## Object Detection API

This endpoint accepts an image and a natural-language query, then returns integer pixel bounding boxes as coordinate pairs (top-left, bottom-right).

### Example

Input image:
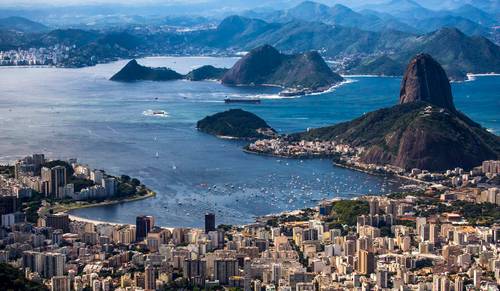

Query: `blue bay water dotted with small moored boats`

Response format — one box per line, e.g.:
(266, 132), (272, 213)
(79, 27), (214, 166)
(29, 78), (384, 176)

(0, 57), (500, 226)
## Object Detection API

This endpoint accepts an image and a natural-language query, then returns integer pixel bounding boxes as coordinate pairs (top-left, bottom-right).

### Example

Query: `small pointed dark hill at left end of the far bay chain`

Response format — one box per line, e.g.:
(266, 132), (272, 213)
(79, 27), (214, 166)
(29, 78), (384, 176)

(110, 60), (184, 82)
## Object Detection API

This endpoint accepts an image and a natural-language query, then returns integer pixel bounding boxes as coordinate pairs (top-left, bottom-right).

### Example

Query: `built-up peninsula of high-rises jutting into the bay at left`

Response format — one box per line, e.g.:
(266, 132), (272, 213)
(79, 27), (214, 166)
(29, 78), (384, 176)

(0, 154), (155, 223)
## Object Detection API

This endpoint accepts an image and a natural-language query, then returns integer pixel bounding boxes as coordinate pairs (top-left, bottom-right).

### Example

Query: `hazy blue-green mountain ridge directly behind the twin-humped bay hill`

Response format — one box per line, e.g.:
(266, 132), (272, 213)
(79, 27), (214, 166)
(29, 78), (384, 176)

(191, 16), (500, 80)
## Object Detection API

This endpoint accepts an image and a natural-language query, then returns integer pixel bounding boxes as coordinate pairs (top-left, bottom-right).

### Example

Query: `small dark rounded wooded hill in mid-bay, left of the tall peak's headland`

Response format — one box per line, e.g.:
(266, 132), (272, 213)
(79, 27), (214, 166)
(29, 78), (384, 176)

(196, 109), (276, 139)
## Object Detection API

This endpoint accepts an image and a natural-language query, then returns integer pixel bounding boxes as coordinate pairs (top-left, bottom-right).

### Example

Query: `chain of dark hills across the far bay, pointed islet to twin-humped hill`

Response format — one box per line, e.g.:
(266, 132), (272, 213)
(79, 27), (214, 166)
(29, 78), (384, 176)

(111, 45), (344, 96)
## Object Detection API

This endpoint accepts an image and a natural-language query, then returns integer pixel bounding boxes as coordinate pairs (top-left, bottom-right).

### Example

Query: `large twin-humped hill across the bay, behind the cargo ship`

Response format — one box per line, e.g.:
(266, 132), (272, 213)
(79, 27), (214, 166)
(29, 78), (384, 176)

(222, 45), (343, 91)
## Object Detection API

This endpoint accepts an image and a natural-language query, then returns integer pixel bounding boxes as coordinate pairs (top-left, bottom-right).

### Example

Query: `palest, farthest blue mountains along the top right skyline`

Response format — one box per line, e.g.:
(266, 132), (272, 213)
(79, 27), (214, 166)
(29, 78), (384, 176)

(242, 0), (500, 37)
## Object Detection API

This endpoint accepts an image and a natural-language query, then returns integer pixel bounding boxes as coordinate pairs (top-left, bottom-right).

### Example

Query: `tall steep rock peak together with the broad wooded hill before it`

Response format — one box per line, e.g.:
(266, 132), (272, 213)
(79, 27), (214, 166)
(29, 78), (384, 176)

(293, 55), (500, 170)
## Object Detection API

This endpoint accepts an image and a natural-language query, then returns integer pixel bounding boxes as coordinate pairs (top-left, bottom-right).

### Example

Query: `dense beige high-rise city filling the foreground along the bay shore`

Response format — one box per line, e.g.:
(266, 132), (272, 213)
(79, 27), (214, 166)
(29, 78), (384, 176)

(0, 154), (500, 291)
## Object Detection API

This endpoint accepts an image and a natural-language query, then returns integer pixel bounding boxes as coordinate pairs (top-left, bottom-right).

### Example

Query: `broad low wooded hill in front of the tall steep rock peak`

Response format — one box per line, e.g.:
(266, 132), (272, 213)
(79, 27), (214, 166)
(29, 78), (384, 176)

(292, 102), (500, 170)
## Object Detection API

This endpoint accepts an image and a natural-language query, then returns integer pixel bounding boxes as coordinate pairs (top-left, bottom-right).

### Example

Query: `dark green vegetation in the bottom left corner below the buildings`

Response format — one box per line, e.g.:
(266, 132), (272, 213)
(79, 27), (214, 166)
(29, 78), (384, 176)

(0, 263), (48, 291)
